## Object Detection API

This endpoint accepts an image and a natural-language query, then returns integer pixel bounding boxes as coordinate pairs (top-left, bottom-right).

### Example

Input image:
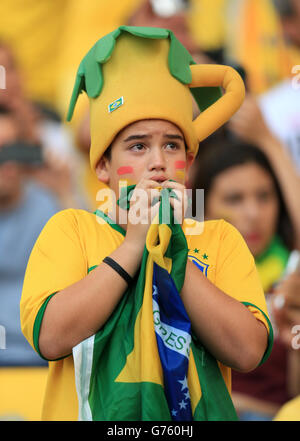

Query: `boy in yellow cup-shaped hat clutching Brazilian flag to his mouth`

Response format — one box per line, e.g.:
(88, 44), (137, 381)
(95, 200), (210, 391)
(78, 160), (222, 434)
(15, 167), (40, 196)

(21, 26), (272, 421)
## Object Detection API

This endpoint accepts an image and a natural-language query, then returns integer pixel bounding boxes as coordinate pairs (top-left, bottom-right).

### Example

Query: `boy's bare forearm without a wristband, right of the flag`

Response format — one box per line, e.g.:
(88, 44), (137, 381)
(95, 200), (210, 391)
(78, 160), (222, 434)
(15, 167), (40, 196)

(181, 260), (267, 372)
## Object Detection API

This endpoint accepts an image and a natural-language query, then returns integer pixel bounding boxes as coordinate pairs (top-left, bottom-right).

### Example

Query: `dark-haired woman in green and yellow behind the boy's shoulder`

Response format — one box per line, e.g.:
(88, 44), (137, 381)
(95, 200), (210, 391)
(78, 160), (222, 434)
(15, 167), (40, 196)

(190, 137), (299, 420)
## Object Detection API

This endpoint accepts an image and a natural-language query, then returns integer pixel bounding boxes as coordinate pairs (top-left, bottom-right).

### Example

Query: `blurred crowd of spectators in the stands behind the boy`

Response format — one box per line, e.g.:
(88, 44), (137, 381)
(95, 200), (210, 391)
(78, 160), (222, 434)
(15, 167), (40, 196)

(0, 0), (300, 421)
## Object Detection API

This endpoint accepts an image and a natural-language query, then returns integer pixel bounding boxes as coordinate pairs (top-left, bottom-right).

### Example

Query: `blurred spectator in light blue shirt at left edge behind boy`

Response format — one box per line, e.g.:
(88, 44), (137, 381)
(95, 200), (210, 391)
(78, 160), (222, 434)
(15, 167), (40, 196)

(0, 107), (61, 366)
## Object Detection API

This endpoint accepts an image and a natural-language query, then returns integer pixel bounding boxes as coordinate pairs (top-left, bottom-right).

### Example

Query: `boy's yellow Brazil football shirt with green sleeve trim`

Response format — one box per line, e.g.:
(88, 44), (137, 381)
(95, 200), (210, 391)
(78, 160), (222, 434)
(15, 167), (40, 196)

(21, 209), (269, 420)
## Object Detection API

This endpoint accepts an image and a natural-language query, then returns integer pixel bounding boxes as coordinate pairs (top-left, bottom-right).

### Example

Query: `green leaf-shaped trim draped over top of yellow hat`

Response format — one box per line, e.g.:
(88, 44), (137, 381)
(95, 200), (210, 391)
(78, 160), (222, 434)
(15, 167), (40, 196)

(67, 26), (221, 121)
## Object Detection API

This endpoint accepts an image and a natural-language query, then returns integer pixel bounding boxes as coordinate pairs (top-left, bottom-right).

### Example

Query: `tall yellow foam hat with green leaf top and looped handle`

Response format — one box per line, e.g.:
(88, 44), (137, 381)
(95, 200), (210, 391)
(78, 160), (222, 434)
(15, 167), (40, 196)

(67, 26), (245, 169)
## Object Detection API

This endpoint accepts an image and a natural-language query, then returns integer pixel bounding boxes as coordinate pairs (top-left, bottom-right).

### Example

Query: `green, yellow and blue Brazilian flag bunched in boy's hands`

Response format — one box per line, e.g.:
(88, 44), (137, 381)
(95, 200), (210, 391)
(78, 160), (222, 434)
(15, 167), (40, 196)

(73, 186), (237, 421)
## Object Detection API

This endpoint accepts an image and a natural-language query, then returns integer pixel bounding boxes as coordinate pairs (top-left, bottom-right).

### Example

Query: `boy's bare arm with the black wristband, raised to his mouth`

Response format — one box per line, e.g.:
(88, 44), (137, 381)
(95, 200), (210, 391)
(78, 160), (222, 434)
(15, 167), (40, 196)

(39, 180), (158, 360)
